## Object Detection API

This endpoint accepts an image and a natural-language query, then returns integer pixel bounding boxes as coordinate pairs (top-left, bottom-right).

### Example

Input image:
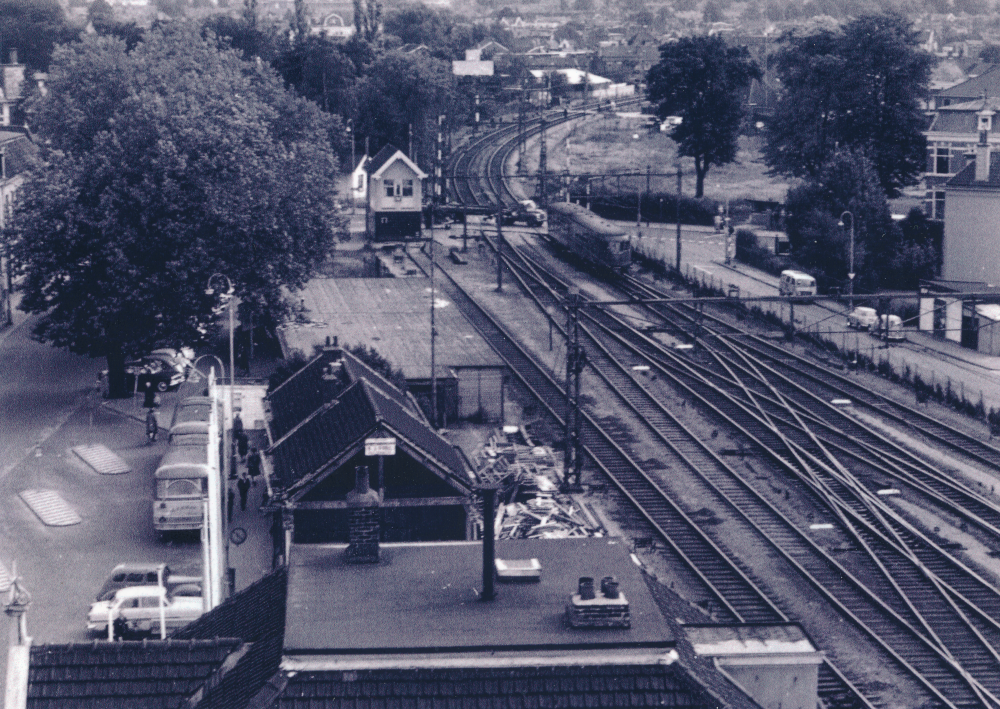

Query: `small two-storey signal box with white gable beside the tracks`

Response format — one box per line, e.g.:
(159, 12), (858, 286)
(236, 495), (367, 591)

(367, 144), (427, 242)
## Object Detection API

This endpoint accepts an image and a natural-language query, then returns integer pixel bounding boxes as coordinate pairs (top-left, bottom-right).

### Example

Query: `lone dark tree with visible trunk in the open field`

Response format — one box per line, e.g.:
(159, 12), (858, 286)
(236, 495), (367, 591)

(646, 35), (761, 197)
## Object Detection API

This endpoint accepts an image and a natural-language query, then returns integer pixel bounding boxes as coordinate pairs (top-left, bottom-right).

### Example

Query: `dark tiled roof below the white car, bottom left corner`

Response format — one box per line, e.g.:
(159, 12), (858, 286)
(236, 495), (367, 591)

(27, 638), (242, 709)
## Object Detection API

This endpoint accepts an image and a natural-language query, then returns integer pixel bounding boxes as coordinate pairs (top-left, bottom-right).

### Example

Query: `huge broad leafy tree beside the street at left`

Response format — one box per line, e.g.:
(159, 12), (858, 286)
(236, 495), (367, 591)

(13, 24), (344, 394)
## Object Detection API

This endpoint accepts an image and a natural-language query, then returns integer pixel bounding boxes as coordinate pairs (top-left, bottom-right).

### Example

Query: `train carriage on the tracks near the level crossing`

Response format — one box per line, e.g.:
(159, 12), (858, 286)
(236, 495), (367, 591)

(548, 202), (632, 273)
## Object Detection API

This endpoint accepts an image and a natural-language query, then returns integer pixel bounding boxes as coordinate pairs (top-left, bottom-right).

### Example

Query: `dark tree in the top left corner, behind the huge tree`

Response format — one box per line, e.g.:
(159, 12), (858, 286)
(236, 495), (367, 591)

(0, 0), (77, 72)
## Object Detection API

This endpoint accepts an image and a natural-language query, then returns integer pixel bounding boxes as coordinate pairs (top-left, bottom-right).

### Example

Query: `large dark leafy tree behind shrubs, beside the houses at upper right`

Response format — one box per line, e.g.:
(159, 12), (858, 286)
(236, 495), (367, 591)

(765, 14), (931, 197)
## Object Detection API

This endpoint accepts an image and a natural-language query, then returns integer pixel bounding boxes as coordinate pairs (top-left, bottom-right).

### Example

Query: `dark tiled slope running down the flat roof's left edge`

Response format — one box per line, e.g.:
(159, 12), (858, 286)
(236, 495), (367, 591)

(174, 567), (288, 709)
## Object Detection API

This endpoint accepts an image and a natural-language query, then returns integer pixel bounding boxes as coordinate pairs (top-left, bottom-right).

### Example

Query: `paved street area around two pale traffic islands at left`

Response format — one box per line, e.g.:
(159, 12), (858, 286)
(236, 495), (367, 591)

(0, 314), (199, 643)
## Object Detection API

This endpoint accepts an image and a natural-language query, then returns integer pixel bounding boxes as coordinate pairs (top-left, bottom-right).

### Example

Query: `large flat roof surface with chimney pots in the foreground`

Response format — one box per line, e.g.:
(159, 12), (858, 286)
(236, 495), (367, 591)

(285, 538), (673, 656)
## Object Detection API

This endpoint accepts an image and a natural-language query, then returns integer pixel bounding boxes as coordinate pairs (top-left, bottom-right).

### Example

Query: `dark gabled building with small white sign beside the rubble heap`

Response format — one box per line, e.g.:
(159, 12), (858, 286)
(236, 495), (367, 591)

(265, 347), (474, 554)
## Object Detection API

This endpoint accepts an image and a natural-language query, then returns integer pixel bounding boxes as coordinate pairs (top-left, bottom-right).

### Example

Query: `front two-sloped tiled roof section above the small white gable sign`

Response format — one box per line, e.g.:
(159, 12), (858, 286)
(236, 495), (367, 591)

(268, 379), (468, 490)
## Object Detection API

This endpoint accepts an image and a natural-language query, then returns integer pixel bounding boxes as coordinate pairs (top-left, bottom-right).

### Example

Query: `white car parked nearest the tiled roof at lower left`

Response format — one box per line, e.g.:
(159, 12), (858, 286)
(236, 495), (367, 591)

(87, 586), (205, 635)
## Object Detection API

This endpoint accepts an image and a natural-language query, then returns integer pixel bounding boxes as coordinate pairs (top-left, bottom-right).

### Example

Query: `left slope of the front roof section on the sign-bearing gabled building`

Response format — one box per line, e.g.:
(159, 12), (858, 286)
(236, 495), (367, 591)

(270, 382), (378, 487)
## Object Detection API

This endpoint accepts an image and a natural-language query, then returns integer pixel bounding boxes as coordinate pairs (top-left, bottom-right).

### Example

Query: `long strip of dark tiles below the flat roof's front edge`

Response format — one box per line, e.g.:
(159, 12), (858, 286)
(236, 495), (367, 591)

(278, 663), (732, 709)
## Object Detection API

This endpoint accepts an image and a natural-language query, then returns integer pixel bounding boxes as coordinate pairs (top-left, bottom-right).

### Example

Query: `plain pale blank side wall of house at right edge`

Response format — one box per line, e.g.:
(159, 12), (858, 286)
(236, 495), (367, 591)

(941, 188), (1000, 288)
